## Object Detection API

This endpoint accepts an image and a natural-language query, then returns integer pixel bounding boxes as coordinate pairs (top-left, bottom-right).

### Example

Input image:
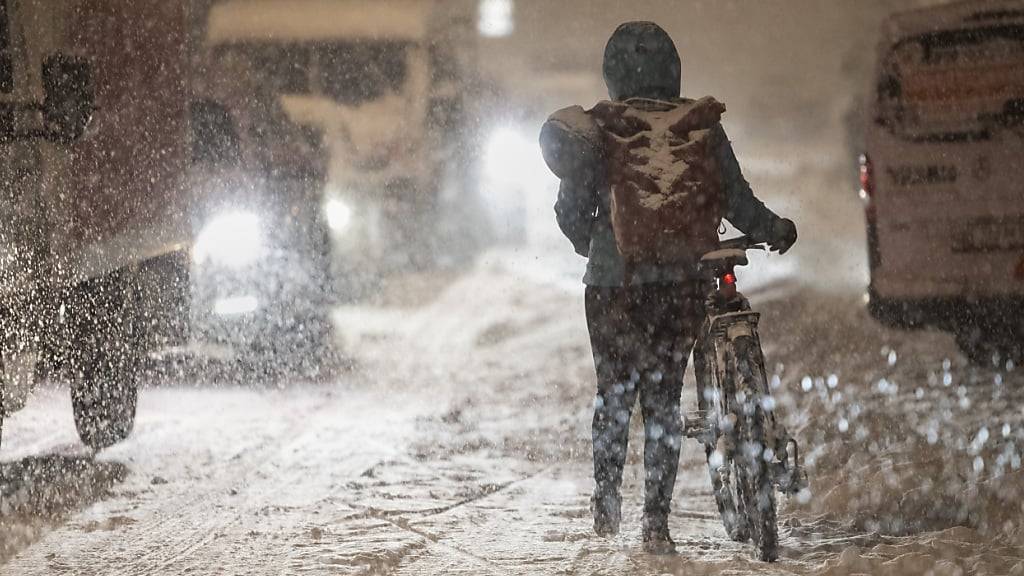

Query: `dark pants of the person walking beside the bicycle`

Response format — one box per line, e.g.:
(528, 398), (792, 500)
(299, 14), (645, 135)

(586, 283), (705, 523)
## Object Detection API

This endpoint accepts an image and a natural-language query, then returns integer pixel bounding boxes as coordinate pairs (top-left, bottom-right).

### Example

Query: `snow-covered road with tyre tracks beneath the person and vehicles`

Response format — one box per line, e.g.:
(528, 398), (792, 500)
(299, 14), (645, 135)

(0, 253), (1024, 576)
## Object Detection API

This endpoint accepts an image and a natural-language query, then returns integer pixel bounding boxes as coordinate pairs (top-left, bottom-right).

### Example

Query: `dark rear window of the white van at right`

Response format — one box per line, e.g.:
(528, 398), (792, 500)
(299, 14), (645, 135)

(878, 25), (1024, 139)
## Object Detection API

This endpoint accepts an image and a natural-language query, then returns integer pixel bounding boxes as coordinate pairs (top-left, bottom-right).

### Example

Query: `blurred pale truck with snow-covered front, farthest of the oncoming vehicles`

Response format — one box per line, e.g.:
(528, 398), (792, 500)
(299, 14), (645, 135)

(206, 0), (475, 284)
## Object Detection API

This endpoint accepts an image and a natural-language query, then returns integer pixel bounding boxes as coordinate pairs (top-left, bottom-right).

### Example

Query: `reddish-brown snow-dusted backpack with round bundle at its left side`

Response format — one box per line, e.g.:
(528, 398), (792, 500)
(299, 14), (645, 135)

(542, 97), (725, 272)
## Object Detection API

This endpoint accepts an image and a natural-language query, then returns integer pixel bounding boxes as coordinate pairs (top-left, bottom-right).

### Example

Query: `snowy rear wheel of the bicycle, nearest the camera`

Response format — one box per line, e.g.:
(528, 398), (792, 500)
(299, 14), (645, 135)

(729, 336), (778, 562)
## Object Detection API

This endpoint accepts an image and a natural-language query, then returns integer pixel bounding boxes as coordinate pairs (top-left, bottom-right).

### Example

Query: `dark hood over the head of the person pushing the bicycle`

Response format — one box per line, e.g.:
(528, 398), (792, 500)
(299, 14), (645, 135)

(604, 22), (682, 100)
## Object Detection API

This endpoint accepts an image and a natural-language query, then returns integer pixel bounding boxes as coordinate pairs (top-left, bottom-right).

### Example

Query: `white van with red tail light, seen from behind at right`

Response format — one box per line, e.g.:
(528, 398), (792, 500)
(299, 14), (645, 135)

(861, 0), (1024, 364)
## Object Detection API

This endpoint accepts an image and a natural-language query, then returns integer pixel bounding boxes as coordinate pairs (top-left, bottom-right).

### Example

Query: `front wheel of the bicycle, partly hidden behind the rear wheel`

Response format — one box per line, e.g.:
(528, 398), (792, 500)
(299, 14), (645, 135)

(693, 331), (750, 542)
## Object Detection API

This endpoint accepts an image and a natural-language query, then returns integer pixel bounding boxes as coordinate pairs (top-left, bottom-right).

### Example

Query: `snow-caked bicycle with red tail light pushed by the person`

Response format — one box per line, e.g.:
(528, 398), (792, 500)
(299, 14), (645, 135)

(684, 236), (807, 562)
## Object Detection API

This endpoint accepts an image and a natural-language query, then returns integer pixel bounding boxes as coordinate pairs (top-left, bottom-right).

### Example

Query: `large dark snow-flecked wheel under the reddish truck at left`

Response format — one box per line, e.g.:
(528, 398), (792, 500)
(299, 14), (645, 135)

(71, 280), (142, 450)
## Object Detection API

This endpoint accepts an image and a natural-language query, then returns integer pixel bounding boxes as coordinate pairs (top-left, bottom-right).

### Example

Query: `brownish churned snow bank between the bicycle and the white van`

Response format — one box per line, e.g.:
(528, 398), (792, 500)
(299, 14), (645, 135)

(755, 287), (1024, 575)
